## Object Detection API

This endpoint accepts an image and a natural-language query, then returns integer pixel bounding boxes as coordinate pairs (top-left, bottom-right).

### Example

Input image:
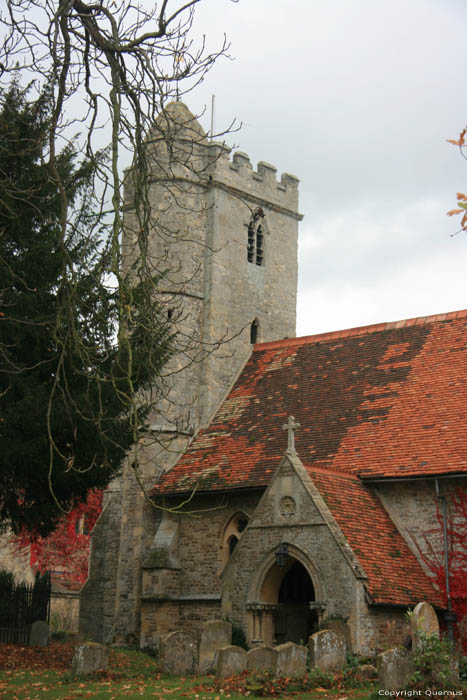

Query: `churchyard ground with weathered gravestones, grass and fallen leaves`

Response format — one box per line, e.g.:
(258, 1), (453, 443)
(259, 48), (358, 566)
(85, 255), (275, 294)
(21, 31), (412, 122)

(0, 603), (467, 700)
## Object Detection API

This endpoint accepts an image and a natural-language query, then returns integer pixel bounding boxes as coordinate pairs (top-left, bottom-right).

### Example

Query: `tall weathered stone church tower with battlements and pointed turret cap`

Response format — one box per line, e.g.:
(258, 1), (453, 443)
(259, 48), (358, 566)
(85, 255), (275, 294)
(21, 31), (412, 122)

(80, 102), (301, 642)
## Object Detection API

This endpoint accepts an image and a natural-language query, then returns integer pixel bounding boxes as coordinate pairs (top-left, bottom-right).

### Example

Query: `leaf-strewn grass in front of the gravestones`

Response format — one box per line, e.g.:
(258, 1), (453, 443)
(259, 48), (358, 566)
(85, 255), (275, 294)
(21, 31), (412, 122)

(0, 643), (371, 700)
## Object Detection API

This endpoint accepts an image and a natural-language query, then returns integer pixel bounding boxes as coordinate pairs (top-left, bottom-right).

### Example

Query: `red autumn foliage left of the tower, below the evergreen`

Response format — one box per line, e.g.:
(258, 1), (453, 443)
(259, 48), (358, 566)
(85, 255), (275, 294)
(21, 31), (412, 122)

(12, 491), (102, 589)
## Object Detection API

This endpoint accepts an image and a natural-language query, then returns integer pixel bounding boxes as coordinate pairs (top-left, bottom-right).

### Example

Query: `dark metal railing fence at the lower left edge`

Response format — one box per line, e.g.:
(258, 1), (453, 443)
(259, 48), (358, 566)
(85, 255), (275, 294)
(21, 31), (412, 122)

(0, 574), (51, 644)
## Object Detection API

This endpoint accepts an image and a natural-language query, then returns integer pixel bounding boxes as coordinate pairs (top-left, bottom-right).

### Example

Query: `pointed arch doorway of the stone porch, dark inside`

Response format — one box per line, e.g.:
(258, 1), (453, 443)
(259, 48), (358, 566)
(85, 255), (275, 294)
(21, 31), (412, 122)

(247, 549), (318, 644)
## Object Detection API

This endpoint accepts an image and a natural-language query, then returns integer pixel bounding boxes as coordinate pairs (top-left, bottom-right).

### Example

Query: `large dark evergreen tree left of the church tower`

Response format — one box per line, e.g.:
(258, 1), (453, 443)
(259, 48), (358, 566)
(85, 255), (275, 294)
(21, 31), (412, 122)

(0, 82), (170, 535)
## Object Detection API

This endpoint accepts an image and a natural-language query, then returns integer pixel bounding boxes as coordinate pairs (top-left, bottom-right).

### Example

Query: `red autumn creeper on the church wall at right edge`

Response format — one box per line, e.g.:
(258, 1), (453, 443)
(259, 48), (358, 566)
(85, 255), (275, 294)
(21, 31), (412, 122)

(417, 487), (467, 654)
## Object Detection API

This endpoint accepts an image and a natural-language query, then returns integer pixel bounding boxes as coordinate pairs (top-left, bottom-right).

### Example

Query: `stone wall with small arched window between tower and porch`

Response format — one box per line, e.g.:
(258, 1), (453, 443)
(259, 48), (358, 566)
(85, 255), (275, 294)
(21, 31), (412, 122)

(140, 492), (259, 647)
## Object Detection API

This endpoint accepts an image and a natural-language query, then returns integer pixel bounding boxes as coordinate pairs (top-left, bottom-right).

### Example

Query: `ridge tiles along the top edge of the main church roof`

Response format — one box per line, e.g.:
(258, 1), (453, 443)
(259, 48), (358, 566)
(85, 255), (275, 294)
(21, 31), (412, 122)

(253, 309), (467, 352)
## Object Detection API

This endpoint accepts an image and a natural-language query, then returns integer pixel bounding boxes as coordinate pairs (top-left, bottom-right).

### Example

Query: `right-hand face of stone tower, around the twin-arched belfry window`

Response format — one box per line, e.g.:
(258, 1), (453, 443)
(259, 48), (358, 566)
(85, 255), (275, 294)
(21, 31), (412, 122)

(203, 144), (301, 416)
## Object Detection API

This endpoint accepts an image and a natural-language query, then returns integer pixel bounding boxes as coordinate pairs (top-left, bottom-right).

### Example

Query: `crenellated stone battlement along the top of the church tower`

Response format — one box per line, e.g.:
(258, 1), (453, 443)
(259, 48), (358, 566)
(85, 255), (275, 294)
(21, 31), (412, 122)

(208, 141), (302, 213)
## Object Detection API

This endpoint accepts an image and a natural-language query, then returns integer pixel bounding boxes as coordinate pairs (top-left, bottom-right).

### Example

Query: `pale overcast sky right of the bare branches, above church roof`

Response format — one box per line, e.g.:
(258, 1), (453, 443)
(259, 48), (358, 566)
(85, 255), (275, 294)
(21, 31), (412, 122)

(186, 0), (467, 335)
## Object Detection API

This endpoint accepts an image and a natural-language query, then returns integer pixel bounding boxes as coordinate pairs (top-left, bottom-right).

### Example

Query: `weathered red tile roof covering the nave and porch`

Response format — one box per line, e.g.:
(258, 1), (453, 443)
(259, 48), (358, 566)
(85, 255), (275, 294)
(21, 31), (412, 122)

(154, 311), (467, 605)
